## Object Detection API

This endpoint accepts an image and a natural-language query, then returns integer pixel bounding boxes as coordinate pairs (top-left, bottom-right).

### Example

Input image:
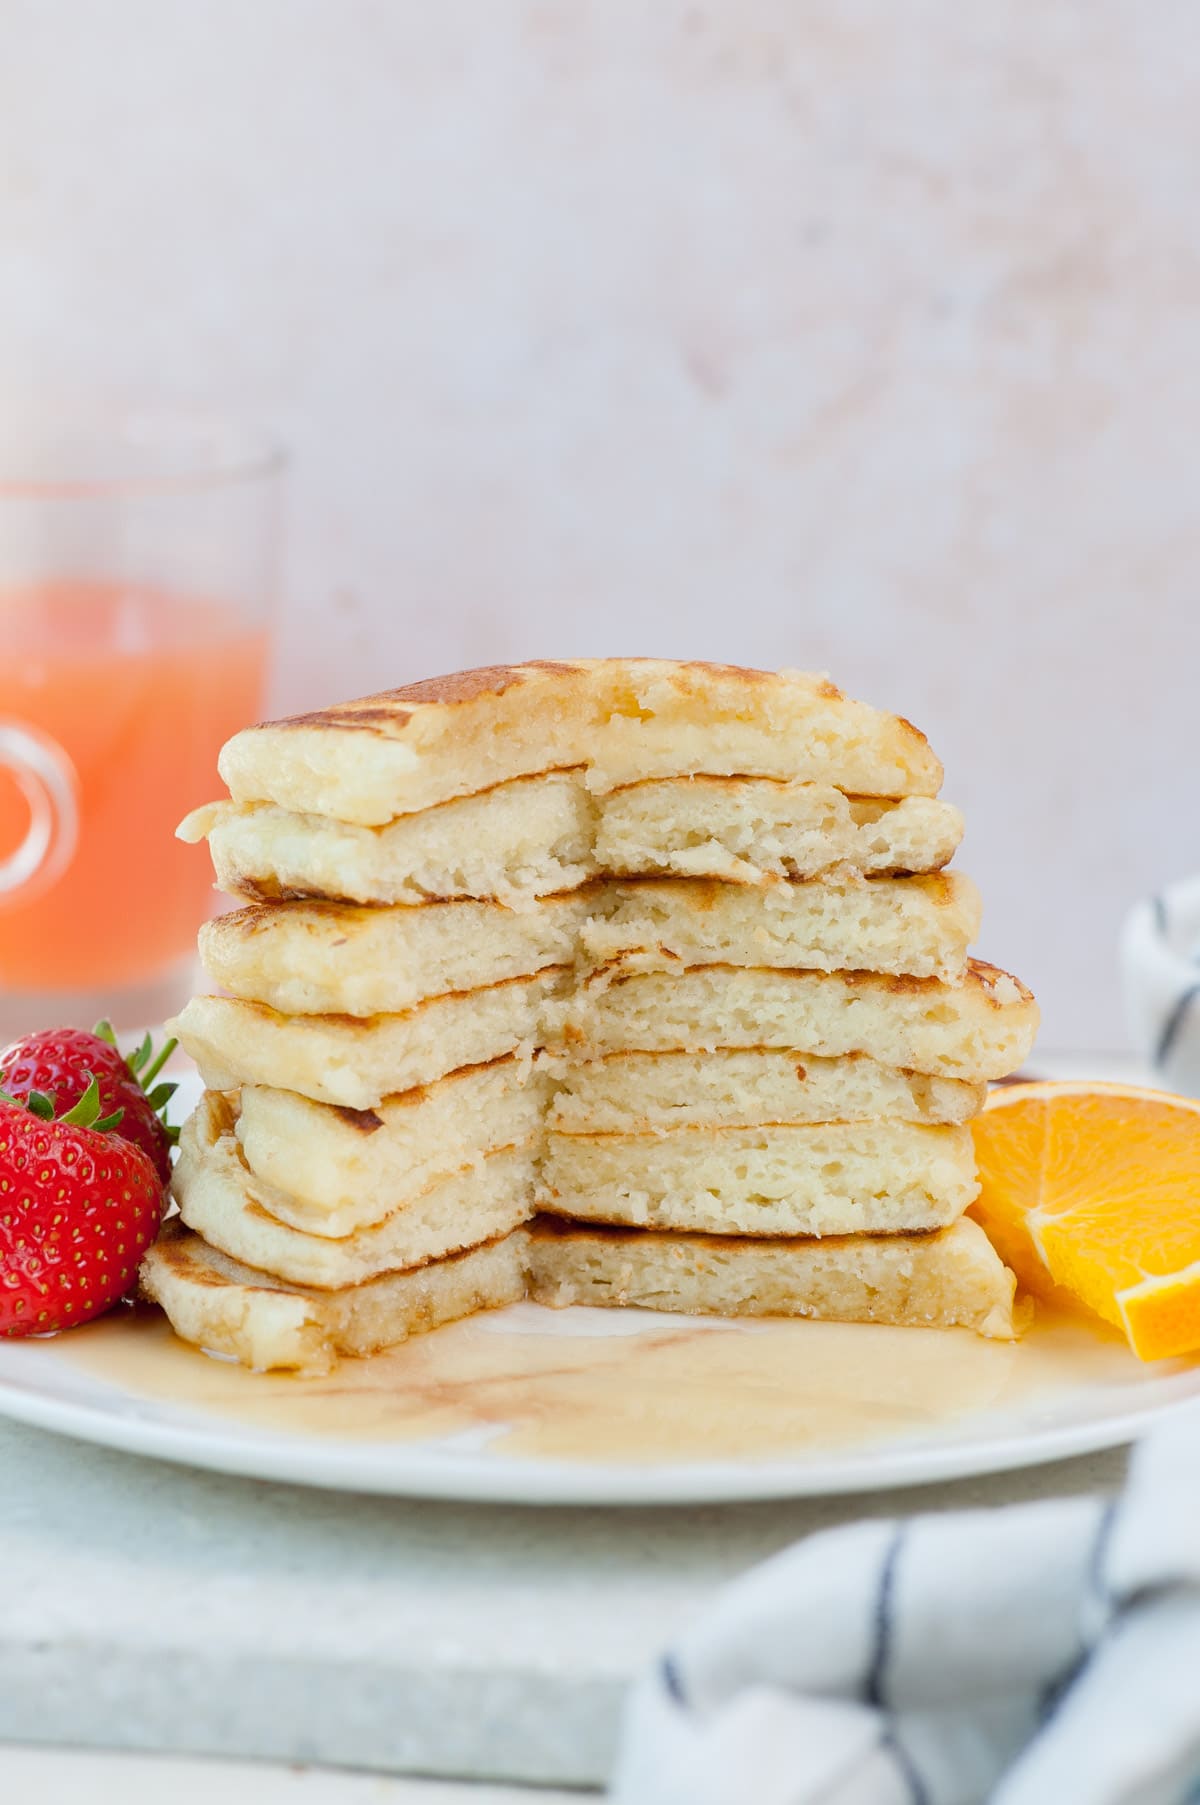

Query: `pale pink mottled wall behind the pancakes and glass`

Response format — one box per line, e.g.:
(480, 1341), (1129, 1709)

(0, 0), (1200, 1047)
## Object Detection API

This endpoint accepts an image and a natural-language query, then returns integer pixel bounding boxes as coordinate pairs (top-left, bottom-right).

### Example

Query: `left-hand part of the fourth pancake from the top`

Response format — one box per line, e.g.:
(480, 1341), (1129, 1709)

(168, 966), (570, 1110)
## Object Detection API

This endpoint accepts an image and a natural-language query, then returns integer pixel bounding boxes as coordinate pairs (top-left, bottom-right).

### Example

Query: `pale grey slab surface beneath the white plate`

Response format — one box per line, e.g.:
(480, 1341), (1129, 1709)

(0, 1424), (1124, 1785)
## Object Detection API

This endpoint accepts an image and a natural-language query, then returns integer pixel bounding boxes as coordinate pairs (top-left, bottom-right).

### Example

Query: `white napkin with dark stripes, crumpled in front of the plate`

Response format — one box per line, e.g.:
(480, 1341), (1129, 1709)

(612, 1410), (1200, 1805)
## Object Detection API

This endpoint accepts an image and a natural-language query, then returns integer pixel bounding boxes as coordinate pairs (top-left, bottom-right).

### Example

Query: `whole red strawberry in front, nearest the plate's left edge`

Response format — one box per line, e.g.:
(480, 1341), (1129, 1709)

(0, 1079), (164, 1338)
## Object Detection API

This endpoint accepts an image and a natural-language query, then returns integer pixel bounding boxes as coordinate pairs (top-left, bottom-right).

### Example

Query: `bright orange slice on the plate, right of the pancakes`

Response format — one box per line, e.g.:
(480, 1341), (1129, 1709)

(971, 1083), (1200, 1359)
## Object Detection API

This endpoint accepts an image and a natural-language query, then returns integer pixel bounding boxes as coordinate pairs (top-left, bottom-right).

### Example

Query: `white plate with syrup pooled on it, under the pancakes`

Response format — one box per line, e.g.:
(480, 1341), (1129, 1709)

(0, 1075), (1200, 1504)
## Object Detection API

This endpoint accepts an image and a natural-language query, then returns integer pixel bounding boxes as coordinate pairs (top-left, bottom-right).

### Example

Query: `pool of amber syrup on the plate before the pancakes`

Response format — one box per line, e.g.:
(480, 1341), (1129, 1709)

(45, 1305), (1144, 1464)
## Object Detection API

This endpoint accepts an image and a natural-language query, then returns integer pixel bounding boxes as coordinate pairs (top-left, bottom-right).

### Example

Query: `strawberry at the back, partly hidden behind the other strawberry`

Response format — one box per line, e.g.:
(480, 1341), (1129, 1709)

(0, 1022), (179, 1184)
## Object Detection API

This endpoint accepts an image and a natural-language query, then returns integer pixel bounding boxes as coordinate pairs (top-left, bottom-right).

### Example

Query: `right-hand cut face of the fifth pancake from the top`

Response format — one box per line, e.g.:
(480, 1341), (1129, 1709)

(543, 1047), (987, 1134)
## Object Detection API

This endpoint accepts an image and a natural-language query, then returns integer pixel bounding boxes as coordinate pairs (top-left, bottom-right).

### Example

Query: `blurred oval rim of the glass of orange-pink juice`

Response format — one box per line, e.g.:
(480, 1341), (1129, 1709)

(0, 413), (289, 504)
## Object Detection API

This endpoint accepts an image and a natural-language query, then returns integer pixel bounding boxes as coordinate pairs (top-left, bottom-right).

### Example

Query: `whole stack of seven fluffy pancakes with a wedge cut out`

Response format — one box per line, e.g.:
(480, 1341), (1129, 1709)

(143, 659), (1036, 1370)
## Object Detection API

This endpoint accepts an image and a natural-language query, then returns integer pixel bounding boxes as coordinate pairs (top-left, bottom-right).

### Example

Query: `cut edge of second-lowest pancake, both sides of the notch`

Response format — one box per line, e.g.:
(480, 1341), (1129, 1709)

(173, 1097), (976, 1249)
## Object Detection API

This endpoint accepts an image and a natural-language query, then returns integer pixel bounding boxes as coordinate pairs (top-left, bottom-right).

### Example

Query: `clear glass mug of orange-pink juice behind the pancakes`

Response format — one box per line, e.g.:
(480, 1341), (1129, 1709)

(0, 419), (283, 1040)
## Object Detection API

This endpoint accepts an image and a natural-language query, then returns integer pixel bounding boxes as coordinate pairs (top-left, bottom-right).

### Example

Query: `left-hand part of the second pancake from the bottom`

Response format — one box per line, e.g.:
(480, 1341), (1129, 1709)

(173, 1097), (532, 1291)
